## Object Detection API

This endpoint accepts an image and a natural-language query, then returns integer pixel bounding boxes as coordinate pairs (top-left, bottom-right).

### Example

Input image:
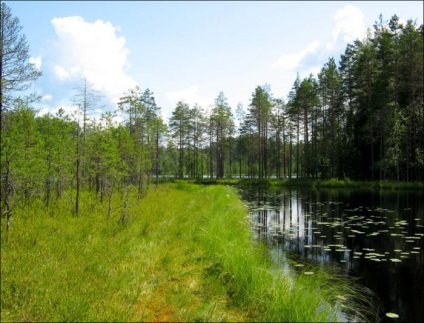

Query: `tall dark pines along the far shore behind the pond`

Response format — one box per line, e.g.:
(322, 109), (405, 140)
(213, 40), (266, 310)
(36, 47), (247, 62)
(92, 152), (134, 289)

(167, 15), (424, 181)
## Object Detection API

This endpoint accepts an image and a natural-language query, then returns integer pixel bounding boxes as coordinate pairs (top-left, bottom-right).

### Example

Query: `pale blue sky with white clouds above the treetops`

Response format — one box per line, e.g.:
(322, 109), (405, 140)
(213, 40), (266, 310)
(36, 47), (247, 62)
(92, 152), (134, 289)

(6, 1), (423, 123)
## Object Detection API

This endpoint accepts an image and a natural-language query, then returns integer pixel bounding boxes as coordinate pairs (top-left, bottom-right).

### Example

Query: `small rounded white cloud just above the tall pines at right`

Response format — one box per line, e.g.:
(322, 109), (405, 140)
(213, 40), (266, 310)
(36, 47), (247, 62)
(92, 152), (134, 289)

(327, 4), (367, 49)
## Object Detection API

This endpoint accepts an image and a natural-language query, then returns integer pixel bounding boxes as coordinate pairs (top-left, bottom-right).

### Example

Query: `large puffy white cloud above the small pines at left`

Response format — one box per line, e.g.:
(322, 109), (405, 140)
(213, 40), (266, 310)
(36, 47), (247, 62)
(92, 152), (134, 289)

(51, 16), (136, 103)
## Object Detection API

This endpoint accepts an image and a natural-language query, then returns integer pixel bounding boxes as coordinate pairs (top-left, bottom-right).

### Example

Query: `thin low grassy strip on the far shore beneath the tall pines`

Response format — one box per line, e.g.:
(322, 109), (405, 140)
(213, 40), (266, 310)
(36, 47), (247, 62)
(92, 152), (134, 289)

(197, 178), (424, 190)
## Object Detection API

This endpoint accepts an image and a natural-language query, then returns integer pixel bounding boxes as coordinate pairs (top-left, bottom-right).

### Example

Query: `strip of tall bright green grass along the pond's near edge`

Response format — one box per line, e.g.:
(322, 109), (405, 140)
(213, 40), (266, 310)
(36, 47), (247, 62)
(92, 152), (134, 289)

(197, 187), (372, 322)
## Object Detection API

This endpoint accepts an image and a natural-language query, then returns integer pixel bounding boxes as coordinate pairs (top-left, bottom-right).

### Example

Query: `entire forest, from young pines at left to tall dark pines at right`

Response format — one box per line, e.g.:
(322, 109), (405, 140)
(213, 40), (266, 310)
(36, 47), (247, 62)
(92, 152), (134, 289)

(1, 4), (424, 223)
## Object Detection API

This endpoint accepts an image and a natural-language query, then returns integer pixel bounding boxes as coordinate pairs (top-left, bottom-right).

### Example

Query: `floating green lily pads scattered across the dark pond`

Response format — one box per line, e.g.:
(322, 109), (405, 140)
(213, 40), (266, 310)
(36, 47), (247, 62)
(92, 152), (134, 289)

(243, 192), (424, 318)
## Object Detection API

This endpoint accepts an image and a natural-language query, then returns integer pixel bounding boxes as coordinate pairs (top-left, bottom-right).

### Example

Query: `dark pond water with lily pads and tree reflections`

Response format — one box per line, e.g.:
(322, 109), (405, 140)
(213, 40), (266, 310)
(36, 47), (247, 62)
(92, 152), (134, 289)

(240, 188), (424, 322)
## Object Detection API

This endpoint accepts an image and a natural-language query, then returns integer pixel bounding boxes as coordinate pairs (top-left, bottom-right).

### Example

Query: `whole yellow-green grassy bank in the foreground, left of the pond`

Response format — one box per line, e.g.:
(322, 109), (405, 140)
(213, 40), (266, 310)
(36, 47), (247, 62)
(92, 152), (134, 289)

(1, 182), (370, 322)
